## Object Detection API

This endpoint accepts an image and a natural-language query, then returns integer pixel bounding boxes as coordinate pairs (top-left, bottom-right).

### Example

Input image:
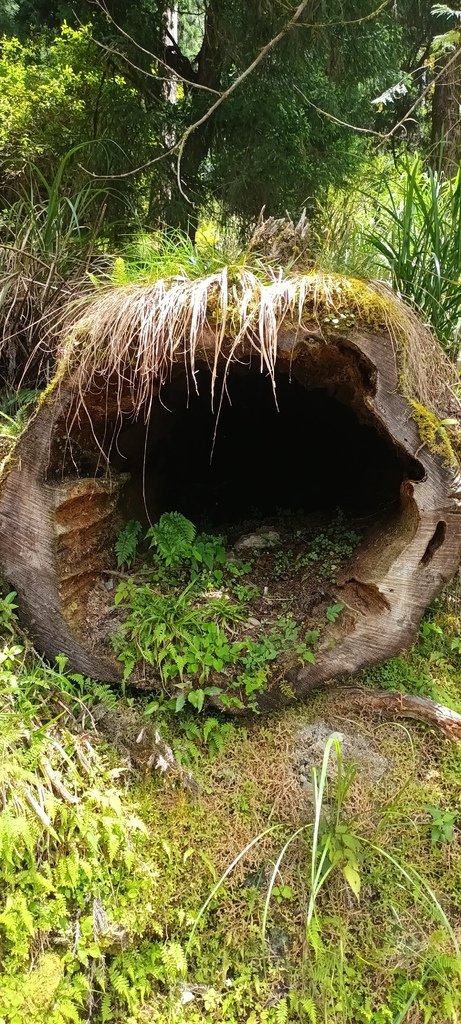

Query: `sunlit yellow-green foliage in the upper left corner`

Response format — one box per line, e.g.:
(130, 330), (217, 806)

(0, 23), (150, 207)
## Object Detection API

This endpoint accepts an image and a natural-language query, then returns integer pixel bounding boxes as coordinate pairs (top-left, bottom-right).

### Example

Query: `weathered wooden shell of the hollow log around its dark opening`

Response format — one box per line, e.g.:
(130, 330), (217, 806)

(0, 268), (461, 708)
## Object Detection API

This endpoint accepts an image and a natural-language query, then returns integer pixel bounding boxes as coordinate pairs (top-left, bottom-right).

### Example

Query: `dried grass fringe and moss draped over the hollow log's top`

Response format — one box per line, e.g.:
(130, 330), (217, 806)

(52, 267), (461, 416)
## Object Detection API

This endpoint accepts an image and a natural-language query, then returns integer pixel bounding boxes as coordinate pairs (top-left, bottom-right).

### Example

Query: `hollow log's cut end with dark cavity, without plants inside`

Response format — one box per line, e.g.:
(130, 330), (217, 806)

(0, 315), (461, 708)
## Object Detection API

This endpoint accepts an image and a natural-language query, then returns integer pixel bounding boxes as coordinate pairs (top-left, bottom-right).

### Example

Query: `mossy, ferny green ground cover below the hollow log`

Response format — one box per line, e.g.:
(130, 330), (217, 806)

(0, 577), (461, 1024)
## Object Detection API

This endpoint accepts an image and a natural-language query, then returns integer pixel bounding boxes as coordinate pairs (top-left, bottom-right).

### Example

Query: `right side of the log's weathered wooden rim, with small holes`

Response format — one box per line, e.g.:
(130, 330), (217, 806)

(261, 332), (461, 709)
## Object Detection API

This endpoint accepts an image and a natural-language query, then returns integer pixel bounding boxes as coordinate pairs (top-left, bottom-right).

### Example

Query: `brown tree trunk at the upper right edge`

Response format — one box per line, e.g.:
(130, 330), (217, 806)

(431, 42), (461, 177)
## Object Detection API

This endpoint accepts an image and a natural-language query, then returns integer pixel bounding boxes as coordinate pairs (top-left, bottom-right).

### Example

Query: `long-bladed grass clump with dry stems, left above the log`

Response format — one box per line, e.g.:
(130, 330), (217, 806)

(0, 147), (107, 381)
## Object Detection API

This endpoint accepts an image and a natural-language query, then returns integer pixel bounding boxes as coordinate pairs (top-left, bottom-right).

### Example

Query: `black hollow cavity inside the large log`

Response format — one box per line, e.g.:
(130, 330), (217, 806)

(111, 366), (420, 527)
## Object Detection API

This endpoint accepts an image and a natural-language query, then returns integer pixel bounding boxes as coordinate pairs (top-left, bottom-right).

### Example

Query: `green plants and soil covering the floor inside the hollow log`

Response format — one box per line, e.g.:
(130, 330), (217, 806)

(112, 512), (350, 712)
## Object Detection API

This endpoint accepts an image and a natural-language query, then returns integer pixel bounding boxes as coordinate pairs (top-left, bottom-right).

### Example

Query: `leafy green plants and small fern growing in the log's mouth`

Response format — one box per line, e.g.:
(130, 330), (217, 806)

(113, 512), (317, 712)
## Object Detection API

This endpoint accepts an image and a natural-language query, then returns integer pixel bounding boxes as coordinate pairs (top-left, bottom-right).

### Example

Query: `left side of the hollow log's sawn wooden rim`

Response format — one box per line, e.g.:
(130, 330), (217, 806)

(0, 395), (124, 679)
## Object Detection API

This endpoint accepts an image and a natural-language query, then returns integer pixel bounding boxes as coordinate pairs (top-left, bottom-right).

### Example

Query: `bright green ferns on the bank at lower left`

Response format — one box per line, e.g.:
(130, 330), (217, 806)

(0, 630), (177, 1024)
